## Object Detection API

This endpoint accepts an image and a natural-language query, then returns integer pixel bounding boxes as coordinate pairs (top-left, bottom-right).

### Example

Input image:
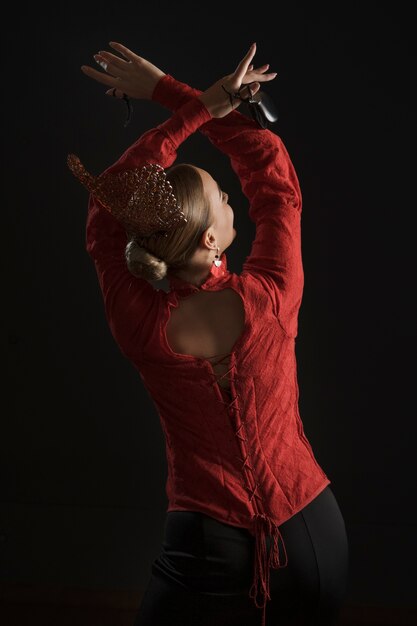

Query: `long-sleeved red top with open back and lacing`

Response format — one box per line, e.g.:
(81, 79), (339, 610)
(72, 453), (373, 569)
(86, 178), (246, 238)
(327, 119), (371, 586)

(86, 75), (330, 626)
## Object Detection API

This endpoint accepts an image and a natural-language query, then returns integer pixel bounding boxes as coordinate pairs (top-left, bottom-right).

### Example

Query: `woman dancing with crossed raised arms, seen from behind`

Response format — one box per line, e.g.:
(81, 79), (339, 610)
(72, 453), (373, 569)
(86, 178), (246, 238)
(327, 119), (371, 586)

(68, 42), (348, 626)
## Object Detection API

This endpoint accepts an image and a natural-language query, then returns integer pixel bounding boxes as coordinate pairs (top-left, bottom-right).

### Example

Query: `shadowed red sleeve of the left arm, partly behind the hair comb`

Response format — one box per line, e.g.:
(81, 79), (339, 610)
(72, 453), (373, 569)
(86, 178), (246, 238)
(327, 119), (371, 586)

(86, 98), (211, 360)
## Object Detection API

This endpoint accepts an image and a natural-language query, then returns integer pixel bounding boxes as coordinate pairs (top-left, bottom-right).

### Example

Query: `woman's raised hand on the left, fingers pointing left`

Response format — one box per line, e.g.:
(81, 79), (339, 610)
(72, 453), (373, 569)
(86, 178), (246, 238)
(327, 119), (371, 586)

(81, 41), (165, 100)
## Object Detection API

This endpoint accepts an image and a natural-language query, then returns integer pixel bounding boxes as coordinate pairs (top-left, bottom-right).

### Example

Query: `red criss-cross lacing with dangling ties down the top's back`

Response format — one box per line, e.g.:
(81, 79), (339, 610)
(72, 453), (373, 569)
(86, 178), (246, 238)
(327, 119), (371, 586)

(204, 353), (288, 626)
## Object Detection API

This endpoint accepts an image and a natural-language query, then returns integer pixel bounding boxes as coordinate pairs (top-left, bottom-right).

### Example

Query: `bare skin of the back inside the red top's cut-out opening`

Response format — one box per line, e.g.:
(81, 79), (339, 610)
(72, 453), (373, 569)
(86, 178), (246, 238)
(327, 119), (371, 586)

(166, 289), (245, 389)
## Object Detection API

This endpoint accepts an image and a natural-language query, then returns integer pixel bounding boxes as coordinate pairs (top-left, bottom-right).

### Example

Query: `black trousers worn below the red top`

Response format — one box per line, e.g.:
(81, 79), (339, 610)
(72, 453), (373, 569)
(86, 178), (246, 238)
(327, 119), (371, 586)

(134, 485), (349, 626)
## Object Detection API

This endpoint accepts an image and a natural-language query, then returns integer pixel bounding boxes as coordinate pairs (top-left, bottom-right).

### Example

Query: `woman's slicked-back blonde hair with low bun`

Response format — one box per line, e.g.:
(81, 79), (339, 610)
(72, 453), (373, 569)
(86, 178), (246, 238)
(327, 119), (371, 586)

(125, 163), (212, 281)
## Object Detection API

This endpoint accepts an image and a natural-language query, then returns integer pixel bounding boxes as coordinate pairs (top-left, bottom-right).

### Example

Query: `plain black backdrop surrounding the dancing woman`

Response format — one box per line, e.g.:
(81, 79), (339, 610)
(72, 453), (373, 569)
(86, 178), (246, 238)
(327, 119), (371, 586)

(0, 2), (416, 606)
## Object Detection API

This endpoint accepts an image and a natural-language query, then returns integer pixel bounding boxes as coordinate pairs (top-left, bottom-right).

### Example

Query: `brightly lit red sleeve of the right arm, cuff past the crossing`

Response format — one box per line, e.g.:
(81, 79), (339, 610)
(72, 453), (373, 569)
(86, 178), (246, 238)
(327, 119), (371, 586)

(153, 74), (304, 336)
